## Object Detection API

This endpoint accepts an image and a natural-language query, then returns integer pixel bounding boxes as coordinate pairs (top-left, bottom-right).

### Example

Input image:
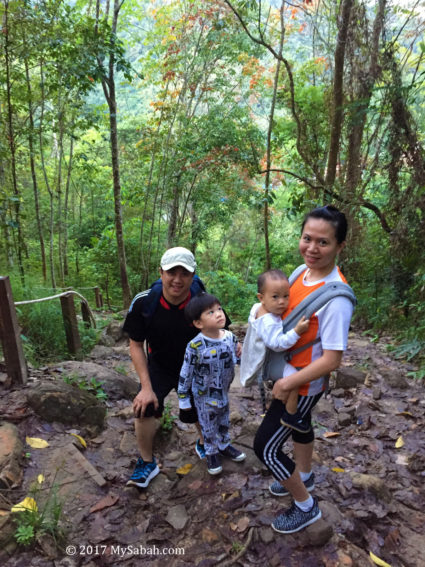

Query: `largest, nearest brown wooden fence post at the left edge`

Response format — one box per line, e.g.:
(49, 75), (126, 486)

(0, 276), (28, 384)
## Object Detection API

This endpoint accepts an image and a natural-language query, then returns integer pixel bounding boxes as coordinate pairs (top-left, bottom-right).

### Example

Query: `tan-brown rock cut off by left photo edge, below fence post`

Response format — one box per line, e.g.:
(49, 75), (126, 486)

(0, 423), (23, 490)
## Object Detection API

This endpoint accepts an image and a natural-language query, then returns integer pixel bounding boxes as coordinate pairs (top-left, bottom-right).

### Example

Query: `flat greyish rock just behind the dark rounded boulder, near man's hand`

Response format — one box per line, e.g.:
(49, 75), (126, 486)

(51, 360), (139, 400)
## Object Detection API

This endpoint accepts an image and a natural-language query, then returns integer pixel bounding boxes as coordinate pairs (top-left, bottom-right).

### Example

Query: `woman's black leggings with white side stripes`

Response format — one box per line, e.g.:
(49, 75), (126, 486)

(254, 392), (322, 480)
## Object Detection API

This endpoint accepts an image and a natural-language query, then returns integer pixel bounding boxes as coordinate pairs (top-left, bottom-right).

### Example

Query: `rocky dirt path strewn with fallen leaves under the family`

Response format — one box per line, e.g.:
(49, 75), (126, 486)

(0, 328), (425, 567)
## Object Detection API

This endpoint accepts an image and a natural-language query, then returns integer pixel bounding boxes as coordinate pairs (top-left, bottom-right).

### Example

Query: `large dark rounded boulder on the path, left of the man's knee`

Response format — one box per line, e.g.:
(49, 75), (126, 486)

(27, 380), (106, 430)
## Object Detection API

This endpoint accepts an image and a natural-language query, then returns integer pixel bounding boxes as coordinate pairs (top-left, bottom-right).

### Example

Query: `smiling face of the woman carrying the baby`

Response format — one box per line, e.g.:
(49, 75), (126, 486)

(299, 218), (345, 275)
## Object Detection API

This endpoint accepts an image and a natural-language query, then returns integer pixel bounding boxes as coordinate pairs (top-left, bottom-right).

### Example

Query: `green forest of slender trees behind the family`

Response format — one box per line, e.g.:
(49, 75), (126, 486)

(0, 0), (425, 370)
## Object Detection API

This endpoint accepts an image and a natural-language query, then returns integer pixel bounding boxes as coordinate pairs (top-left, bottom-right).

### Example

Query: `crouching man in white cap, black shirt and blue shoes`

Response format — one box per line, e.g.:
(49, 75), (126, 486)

(123, 247), (205, 488)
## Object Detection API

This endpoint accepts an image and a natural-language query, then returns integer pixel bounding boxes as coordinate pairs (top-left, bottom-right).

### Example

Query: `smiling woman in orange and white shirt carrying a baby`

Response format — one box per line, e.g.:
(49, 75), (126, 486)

(254, 205), (353, 533)
